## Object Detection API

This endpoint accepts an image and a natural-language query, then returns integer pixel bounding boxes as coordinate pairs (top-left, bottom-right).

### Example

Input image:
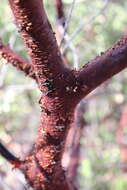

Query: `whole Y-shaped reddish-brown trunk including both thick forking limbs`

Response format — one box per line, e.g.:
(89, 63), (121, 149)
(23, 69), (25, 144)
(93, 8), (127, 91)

(0, 0), (127, 190)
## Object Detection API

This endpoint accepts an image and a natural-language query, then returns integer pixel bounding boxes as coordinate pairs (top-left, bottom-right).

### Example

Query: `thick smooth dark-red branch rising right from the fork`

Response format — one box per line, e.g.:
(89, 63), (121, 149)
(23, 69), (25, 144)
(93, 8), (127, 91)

(77, 36), (127, 97)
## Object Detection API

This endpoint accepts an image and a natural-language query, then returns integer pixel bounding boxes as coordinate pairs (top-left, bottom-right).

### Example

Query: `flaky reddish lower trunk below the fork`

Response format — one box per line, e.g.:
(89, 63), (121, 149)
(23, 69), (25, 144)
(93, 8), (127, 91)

(20, 97), (77, 190)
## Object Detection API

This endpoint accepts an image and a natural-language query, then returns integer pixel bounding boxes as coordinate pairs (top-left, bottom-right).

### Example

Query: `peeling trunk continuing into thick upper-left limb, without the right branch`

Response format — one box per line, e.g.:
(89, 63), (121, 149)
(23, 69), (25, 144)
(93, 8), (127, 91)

(9, 0), (77, 190)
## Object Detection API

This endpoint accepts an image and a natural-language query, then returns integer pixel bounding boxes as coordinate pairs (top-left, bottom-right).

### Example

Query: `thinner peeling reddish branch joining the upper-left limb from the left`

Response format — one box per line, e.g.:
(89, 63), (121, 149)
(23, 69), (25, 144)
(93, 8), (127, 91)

(0, 41), (37, 80)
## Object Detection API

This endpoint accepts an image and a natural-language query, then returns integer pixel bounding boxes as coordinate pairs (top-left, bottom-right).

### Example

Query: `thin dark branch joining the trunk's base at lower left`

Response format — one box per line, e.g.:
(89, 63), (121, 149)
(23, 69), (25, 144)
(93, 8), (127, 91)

(0, 142), (22, 168)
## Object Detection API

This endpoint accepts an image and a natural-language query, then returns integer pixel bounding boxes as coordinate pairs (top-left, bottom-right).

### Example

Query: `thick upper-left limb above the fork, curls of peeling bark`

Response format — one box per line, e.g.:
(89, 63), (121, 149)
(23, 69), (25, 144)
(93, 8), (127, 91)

(9, 0), (72, 95)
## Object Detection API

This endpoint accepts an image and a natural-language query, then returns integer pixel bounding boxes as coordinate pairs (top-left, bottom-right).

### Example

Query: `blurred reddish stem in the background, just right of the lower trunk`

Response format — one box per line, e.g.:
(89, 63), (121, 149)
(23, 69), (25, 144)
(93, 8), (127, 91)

(67, 100), (87, 186)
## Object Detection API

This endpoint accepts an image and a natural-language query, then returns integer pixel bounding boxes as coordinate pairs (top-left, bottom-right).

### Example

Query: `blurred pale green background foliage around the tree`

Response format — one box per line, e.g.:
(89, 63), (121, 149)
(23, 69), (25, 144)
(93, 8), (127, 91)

(0, 0), (127, 190)
